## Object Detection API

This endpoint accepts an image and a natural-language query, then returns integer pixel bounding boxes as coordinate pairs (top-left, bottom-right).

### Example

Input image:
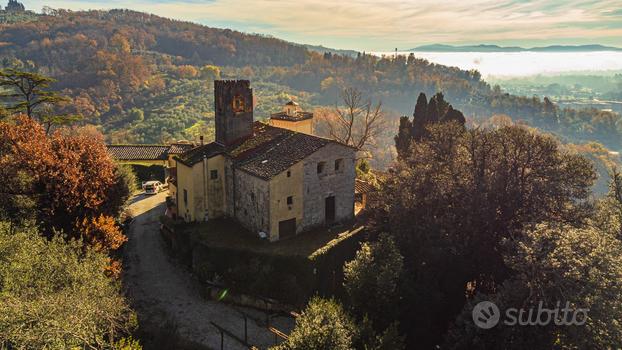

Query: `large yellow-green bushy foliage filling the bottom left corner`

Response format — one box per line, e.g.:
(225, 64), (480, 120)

(0, 223), (136, 349)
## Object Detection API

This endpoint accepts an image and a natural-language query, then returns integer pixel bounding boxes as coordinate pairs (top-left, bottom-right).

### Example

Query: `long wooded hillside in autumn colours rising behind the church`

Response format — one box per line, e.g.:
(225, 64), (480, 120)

(0, 9), (622, 157)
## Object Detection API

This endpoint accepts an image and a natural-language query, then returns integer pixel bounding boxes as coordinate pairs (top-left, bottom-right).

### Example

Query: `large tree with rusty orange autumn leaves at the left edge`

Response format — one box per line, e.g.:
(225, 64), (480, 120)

(0, 116), (127, 250)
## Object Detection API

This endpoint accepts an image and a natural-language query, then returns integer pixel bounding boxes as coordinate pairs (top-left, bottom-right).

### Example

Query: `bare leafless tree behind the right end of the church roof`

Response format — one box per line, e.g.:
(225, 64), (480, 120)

(320, 88), (385, 157)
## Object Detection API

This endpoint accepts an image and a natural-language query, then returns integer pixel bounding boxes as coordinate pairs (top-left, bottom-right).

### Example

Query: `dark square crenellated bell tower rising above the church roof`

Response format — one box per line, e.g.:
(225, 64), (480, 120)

(214, 80), (253, 146)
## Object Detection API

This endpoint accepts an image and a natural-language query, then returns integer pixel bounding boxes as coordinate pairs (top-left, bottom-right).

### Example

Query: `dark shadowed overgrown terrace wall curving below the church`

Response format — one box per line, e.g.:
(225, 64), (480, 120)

(162, 221), (367, 308)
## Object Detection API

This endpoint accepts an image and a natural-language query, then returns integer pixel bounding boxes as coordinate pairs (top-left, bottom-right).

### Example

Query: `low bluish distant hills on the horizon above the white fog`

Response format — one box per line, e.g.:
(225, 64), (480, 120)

(408, 44), (622, 52)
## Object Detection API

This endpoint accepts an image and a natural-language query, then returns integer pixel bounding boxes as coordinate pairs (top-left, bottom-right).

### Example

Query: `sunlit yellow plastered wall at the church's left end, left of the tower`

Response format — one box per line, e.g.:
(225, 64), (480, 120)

(177, 155), (226, 221)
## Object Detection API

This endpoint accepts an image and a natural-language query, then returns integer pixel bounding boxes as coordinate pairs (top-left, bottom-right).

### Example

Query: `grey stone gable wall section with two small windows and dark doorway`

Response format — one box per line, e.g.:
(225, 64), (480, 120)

(302, 143), (356, 230)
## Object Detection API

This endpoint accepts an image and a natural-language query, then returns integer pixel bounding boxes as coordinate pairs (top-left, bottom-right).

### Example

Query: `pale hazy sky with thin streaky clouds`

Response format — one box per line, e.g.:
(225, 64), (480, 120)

(23, 0), (622, 51)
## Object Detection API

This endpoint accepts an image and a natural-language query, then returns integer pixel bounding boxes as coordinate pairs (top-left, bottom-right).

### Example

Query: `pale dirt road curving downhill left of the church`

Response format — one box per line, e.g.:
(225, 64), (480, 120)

(123, 193), (293, 349)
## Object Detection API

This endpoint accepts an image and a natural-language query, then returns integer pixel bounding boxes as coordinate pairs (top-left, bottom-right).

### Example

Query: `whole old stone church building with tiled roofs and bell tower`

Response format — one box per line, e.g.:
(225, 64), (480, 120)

(171, 80), (356, 241)
